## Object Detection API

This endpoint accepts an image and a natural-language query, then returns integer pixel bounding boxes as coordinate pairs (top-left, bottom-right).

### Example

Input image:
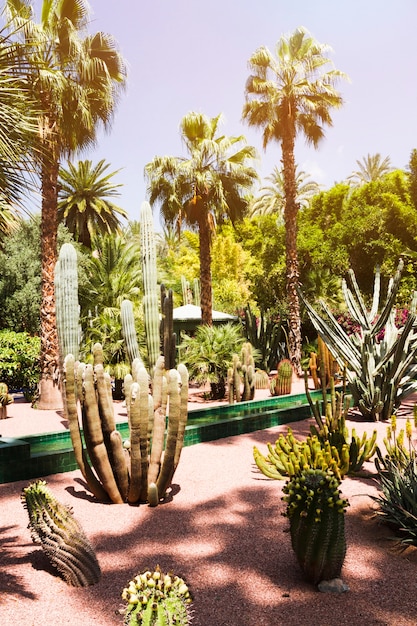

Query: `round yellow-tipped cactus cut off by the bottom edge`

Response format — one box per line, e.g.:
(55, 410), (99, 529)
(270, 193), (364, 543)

(122, 565), (192, 626)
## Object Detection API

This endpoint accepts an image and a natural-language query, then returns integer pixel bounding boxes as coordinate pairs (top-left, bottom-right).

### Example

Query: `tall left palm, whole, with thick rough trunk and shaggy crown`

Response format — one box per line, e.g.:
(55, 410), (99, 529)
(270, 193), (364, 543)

(6, 0), (125, 409)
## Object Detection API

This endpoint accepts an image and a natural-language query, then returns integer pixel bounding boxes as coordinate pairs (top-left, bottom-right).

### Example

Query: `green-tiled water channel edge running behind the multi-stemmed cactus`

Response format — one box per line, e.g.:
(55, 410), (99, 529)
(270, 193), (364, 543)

(0, 392), (321, 483)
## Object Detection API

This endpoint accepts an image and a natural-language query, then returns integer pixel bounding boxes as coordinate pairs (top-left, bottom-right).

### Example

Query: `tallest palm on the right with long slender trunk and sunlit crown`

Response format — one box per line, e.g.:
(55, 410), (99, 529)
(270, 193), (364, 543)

(243, 28), (345, 372)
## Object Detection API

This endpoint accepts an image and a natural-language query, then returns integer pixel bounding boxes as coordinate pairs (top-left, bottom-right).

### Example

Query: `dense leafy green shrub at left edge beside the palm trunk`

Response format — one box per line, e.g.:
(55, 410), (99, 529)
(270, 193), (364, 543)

(0, 330), (40, 399)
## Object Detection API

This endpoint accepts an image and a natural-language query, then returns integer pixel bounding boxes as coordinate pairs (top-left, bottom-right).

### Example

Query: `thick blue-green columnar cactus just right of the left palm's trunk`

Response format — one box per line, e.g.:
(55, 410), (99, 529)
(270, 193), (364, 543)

(54, 243), (80, 363)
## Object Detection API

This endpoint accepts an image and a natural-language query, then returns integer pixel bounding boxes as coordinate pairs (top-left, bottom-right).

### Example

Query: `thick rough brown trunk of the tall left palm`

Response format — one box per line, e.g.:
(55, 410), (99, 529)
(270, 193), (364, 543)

(37, 151), (62, 410)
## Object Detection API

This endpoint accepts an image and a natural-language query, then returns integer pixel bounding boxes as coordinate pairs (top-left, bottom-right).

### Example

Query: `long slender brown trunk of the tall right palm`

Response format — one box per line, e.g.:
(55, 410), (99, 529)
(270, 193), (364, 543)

(282, 124), (302, 375)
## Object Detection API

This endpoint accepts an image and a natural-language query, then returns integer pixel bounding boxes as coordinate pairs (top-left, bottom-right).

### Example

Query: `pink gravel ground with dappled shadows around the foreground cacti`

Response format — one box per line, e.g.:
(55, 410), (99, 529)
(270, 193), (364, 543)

(0, 382), (417, 626)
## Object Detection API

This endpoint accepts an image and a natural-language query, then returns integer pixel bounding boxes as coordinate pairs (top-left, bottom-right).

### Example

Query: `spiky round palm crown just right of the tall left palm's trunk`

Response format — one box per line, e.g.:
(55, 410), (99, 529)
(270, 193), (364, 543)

(58, 159), (127, 249)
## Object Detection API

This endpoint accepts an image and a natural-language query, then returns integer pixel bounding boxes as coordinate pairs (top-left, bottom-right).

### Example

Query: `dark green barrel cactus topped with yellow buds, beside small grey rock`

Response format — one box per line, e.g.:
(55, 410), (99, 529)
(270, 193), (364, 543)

(283, 468), (348, 584)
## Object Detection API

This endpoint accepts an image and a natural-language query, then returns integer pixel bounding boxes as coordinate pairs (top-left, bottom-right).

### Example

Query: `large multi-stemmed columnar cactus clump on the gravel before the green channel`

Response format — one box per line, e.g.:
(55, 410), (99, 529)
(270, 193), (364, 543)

(64, 344), (188, 506)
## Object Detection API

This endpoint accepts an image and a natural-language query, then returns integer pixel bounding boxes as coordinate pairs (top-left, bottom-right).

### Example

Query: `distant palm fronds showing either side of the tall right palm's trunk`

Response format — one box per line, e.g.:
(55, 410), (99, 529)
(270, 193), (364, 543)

(250, 167), (320, 217)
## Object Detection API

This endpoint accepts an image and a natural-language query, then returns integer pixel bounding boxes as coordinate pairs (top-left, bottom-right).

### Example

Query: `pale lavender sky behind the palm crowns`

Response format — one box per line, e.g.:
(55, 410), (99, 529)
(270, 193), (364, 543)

(66, 0), (417, 225)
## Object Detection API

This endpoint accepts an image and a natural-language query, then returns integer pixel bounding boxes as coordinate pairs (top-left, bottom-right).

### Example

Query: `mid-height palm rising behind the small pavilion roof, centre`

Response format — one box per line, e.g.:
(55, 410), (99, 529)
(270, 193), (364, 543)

(145, 112), (257, 325)
